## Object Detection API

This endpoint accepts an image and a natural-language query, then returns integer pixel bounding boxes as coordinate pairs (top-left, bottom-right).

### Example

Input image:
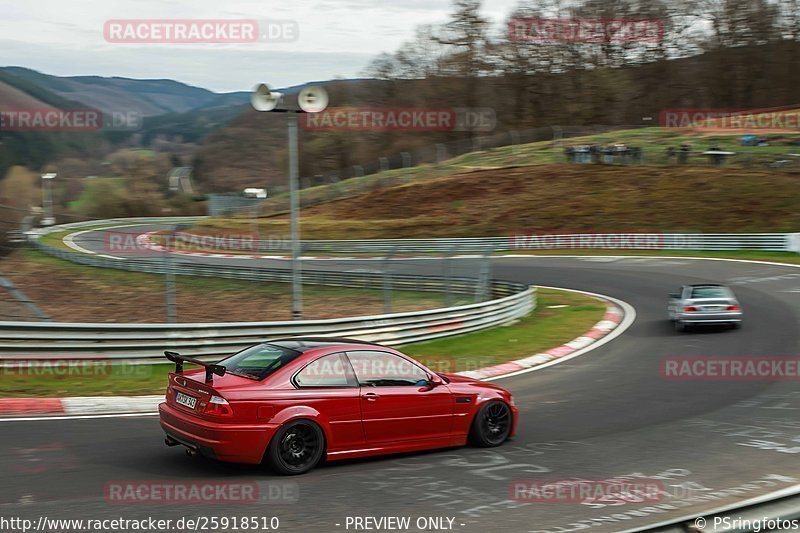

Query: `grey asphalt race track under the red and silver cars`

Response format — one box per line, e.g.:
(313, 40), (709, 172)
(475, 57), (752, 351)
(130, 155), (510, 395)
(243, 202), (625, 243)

(0, 224), (800, 532)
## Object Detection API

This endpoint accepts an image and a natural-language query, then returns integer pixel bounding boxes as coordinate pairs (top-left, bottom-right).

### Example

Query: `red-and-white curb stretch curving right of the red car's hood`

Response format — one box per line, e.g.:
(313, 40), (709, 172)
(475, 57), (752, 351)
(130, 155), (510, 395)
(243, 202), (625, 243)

(457, 302), (625, 379)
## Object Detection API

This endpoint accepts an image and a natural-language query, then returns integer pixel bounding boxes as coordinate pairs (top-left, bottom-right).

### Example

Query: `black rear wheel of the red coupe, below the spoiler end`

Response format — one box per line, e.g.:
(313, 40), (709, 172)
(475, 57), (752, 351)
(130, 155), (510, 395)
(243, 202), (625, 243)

(266, 419), (325, 476)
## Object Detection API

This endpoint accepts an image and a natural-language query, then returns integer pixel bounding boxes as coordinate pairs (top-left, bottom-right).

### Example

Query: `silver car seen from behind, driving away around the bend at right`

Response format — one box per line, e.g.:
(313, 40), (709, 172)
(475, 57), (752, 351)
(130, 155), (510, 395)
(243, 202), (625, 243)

(667, 283), (742, 331)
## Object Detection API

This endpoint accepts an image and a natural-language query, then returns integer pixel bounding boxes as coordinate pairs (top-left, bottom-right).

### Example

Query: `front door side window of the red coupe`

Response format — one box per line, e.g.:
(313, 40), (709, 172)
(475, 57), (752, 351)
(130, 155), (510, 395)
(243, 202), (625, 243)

(347, 350), (428, 387)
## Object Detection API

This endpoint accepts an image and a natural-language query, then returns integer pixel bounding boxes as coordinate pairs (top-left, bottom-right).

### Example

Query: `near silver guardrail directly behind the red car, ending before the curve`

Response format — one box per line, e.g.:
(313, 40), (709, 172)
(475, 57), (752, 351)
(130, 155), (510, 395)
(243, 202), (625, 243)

(0, 282), (536, 360)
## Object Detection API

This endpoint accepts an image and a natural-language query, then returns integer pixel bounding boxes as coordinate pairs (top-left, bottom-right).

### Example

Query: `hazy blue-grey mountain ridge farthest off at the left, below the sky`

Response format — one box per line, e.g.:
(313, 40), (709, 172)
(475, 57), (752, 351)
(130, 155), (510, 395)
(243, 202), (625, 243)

(0, 67), (250, 117)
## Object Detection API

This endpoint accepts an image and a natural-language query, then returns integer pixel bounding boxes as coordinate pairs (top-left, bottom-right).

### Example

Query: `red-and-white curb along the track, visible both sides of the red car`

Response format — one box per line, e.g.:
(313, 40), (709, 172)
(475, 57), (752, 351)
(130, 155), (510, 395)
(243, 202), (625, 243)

(0, 301), (625, 417)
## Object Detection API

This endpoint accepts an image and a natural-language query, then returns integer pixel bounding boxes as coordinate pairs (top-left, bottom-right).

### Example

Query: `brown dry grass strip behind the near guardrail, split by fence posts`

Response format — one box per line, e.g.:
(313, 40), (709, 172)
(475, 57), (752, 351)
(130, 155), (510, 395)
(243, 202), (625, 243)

(4, 249), (460, 323)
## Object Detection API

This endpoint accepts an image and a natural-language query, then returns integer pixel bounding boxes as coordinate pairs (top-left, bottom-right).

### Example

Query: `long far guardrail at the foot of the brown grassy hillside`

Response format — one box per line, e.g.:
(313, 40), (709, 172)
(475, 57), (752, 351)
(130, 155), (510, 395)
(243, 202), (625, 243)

(169, 233), (798, 253)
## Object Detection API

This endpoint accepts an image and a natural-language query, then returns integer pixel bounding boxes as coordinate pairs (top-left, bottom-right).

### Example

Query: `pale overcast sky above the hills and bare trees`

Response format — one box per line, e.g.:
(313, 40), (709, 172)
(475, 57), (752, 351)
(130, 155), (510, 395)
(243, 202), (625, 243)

(0, 0), (517, 92)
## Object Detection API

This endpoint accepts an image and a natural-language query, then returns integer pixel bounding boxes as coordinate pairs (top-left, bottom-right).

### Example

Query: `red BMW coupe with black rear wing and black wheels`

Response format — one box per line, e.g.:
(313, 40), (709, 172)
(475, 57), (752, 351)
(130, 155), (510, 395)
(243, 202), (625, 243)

(159, 337), (518, 475)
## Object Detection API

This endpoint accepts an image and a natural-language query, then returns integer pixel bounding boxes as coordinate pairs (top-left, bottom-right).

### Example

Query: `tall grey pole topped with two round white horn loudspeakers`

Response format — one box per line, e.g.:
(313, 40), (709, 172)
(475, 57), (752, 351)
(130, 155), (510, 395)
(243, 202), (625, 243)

(250, 83), (328, 320)
